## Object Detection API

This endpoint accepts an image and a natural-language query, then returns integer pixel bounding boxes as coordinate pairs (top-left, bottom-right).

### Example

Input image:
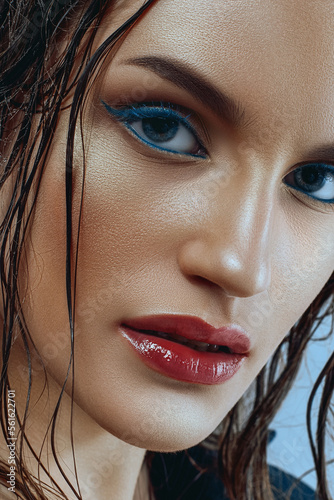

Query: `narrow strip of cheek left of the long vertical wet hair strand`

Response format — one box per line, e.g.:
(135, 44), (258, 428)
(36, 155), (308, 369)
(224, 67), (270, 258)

(19, 166), (70, 383)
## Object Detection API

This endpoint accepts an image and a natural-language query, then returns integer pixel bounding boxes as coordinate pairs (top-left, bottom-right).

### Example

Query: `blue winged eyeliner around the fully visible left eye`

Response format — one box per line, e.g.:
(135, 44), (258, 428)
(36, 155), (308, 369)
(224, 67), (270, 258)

(101, 100), (207, 159)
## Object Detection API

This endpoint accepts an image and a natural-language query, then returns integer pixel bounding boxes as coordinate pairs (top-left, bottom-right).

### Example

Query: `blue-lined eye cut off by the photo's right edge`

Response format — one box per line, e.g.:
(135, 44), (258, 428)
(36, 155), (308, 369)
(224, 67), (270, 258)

(284, 163), (334, 203)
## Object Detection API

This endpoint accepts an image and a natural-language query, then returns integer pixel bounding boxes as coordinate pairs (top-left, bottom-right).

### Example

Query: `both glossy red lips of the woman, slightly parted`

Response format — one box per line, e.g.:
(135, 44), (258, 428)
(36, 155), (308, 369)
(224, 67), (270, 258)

(120, 314), (250, 385)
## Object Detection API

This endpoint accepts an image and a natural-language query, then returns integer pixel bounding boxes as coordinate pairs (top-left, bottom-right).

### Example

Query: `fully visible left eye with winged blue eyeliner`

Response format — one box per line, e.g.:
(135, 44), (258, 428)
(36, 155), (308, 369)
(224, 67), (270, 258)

(102, 101), (207, 158)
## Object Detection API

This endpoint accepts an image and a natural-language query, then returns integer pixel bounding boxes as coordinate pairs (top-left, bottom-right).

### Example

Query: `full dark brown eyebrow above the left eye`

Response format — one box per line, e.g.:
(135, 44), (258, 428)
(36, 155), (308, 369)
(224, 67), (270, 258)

(125, 56), (246, 127)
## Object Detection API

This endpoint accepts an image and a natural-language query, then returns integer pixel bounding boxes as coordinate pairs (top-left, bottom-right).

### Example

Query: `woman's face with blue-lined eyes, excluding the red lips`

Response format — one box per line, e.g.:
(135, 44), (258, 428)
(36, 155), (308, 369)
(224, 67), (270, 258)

(14, 0), (334, 451)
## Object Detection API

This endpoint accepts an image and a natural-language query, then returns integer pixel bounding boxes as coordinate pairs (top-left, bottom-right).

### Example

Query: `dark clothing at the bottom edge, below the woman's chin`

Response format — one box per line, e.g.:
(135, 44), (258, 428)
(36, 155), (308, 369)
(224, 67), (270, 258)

(151, 446), (317, 500)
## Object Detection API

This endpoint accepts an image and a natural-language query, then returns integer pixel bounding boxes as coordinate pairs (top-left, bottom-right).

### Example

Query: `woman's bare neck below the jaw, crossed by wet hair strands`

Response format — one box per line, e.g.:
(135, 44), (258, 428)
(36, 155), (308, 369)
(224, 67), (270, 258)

(0, 342), (148, 500)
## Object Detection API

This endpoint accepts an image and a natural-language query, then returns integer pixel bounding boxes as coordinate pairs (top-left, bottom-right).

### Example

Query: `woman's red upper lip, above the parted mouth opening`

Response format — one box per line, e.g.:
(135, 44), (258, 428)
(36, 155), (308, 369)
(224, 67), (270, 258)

(122, 314), (251, 354)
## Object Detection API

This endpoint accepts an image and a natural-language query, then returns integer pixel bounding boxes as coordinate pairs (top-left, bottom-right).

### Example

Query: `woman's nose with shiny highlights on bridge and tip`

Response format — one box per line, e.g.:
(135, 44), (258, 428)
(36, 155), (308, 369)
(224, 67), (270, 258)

(178, 175), (274, 297)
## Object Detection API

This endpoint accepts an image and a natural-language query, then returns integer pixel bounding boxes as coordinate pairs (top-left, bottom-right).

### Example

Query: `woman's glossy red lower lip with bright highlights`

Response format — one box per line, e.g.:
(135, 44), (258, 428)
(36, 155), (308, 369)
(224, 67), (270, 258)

(121, 325), (246, 385)
